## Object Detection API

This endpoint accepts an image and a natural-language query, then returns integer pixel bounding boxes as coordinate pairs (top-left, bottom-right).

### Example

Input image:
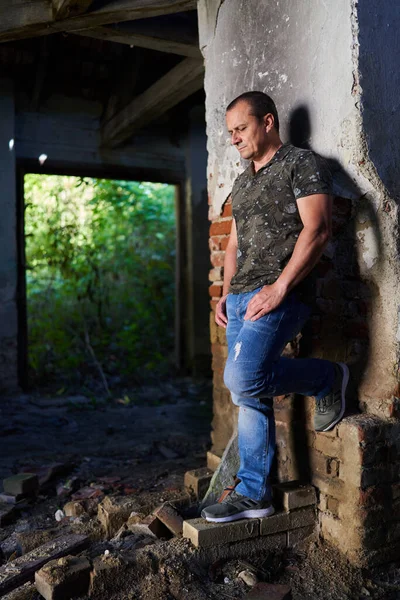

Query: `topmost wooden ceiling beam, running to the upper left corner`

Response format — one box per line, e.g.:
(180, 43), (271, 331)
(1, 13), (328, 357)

(0, 0), (197, 42)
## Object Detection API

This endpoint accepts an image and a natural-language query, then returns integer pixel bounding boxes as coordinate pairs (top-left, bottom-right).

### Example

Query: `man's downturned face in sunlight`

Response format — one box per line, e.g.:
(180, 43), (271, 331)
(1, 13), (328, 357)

(226, 101), (270, 160)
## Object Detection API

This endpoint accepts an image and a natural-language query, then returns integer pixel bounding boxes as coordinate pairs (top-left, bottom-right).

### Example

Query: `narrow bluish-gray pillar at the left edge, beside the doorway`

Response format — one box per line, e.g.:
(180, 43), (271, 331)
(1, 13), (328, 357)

(0, 80), (18, 391)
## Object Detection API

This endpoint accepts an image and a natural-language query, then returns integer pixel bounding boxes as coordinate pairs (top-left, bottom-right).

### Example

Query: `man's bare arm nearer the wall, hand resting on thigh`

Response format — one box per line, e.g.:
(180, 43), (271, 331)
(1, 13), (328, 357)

(244, 194), (332, 321)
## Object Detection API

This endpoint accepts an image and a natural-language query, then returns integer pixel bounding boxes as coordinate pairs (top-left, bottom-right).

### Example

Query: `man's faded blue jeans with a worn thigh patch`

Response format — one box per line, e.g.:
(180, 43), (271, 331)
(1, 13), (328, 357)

(224, 288), (335, 500)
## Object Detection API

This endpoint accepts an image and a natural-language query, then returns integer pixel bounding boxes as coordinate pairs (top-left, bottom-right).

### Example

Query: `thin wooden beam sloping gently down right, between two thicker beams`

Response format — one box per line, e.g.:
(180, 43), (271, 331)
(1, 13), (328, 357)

(72, 27), (201, 58)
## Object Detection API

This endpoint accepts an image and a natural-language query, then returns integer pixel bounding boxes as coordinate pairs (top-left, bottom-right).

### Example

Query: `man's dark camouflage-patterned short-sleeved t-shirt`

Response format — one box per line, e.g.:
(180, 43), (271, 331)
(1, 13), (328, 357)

(229, 144), (331, 295)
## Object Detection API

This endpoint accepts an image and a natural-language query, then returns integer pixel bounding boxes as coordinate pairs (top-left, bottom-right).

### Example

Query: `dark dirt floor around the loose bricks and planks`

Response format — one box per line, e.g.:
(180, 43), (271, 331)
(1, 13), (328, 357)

(0, 379), (400, 600)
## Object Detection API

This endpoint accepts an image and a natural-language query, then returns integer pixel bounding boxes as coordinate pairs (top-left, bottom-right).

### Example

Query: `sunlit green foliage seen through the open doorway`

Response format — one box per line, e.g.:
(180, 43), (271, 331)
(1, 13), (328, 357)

(25, 174), (175, 390)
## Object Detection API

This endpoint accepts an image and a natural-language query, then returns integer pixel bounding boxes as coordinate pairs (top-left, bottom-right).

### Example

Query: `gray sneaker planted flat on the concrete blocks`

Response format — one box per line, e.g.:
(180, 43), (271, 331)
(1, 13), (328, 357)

(201, 490), (275, 523)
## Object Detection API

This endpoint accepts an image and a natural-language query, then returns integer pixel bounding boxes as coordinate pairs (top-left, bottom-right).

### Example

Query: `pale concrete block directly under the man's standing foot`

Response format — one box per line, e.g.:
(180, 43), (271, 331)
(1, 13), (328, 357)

(183, 519), (260, 548)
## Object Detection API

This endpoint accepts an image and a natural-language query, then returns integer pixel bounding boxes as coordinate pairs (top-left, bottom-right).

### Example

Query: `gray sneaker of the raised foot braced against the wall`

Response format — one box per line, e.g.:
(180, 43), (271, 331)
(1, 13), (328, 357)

(314, 363), (349, 431)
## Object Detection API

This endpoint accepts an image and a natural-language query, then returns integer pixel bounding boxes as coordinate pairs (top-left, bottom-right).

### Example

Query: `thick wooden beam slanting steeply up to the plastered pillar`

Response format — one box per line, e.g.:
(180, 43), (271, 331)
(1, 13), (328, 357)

(101, 58), (204, 146)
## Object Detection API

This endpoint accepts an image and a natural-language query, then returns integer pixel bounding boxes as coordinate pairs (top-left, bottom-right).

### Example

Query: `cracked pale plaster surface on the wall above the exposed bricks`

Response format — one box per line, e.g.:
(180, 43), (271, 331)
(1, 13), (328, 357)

(198, 0), (400, 416)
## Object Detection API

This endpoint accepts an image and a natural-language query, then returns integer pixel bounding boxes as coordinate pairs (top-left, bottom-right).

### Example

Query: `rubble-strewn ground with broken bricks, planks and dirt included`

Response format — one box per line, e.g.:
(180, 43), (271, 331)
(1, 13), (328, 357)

(0, 379), (400, 600)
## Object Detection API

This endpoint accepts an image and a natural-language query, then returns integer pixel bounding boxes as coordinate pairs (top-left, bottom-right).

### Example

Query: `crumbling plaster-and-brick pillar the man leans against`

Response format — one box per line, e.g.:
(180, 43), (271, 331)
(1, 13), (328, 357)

(198, 0), (400, 562)
